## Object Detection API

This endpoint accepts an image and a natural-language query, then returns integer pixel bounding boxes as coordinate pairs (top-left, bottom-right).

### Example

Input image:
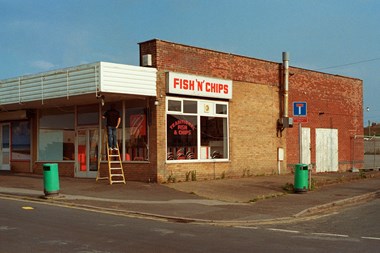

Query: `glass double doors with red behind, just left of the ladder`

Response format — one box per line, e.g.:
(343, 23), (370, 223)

(75, 128), (99, 178)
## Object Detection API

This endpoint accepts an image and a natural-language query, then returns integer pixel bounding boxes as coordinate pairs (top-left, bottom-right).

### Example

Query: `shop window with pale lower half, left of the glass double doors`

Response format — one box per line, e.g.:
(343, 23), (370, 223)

(38, 107), (75, 161)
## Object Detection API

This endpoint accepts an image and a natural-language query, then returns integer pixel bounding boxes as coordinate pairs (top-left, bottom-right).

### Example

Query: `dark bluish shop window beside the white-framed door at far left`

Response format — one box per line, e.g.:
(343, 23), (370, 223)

(12, 121), (30, 160)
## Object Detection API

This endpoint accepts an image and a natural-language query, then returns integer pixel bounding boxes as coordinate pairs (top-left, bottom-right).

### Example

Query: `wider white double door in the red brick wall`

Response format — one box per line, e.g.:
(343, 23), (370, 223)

(316, 128), (338, 172)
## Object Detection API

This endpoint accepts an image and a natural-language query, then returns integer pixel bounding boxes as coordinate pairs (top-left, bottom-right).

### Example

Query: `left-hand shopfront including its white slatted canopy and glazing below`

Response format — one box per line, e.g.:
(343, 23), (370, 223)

(0, 62), (156, 178)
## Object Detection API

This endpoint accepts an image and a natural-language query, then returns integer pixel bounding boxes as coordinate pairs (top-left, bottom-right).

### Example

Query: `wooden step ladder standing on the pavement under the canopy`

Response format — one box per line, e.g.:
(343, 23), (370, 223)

(96, 129), (126, 185)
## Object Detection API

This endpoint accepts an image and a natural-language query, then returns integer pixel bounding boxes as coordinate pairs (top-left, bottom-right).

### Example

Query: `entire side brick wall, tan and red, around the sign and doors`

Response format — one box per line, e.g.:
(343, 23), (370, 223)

(140, 40), (363, 181)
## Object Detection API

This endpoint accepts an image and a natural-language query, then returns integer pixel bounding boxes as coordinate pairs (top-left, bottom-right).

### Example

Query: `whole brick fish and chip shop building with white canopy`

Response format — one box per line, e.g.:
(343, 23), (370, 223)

(0, 39), (363, 182)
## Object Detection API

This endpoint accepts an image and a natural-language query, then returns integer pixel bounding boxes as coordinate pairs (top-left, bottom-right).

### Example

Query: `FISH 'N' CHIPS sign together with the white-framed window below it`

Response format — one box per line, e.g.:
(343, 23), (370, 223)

(166, 72), (232, 162)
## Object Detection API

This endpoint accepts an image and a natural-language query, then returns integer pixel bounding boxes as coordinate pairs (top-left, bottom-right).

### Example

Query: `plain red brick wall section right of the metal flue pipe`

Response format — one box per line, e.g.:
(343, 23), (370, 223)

(287, 68), (364, 170)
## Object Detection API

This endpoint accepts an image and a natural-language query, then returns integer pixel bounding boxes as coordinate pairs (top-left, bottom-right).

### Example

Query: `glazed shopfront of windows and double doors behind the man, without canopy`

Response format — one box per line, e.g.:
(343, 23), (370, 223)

(37, 97), (149, 178)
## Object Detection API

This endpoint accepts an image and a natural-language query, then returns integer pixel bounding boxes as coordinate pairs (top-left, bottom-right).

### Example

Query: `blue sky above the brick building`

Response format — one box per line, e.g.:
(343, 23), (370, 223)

(0, 0), (380, 124)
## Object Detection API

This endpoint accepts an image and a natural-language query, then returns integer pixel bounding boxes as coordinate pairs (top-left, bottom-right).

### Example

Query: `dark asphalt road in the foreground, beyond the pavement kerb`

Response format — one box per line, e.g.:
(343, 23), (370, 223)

(0, 199), (380, 253)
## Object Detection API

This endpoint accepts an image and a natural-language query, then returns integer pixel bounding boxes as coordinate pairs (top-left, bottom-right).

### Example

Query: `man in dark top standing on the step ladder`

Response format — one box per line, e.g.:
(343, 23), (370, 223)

(103, 104), (121, 150)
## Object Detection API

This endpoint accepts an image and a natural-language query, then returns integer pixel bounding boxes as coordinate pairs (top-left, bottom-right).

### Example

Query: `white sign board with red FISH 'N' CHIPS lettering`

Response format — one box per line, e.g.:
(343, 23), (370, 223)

(167, 72), (232, 99)
